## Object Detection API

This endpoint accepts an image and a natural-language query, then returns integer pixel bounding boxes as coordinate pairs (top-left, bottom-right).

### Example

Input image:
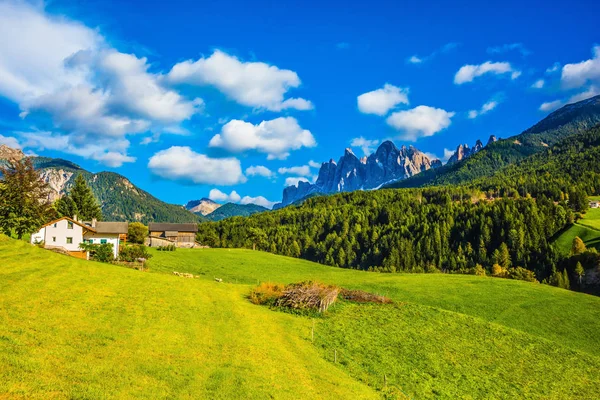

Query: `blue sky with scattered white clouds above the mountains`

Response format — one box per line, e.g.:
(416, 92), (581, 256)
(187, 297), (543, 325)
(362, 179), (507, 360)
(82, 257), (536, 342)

(0, 0), (600, 204)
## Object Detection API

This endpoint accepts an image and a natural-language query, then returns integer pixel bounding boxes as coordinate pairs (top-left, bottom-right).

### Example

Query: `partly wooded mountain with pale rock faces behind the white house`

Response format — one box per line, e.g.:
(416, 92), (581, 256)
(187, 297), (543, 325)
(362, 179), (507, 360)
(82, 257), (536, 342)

(0, 150), (205, 224)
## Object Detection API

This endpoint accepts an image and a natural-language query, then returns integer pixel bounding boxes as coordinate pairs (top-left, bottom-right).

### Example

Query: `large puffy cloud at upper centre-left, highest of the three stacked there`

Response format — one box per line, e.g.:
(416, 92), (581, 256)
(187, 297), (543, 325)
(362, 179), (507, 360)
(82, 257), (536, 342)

(168, 50), (313, 111)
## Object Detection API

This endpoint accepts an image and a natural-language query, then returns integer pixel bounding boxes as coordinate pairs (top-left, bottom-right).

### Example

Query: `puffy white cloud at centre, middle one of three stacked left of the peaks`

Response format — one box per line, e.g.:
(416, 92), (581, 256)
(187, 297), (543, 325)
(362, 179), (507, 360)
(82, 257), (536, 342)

(209, 117), (317, 159)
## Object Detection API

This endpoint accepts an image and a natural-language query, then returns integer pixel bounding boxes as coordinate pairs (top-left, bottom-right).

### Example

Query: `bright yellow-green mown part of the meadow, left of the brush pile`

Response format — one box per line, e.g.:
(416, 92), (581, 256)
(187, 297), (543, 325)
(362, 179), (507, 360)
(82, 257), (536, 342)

(0, 237), (376, 399)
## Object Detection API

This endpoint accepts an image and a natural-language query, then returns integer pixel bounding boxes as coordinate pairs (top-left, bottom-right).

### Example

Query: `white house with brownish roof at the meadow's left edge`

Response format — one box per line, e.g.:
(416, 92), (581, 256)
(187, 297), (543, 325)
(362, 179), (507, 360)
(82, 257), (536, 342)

(31, 217), (129, 258)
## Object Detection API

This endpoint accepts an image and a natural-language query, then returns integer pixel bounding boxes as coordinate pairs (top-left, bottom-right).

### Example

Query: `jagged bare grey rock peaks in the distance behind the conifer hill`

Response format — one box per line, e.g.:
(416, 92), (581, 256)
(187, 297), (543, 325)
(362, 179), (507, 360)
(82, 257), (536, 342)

(275, 140), (442, 208)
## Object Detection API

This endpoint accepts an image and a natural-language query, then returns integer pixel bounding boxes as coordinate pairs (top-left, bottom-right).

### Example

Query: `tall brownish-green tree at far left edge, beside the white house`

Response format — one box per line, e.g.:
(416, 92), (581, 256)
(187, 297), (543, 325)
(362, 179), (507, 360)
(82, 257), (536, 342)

(0, 158), (55, 239)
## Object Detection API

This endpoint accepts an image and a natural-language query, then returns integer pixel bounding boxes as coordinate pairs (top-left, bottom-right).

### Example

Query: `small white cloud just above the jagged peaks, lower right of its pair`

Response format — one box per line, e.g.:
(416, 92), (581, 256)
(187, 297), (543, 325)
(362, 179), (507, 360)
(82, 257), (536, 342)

(386, 106), (455, 141)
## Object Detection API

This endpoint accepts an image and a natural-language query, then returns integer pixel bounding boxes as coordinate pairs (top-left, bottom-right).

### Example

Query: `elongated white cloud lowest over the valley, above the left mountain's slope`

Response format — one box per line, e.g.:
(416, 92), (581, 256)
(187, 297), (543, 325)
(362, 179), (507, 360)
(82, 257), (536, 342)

(148, 146), (246, 185)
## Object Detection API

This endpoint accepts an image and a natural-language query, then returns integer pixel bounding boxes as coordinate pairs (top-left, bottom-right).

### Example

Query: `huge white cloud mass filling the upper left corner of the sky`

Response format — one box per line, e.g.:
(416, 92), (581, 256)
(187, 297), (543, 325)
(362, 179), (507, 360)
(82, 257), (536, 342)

(0, 0), (203, 166)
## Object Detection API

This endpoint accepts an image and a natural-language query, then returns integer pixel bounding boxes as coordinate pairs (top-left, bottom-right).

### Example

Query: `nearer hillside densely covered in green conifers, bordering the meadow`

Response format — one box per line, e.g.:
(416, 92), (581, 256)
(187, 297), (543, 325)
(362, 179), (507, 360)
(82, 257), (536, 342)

(198, 124), (600, 290)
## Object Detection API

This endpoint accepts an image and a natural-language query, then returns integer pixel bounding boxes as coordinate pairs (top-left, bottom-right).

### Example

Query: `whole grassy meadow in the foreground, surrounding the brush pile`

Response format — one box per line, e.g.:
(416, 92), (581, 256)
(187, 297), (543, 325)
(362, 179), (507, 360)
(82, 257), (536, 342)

(0, 238), (600, 399)
